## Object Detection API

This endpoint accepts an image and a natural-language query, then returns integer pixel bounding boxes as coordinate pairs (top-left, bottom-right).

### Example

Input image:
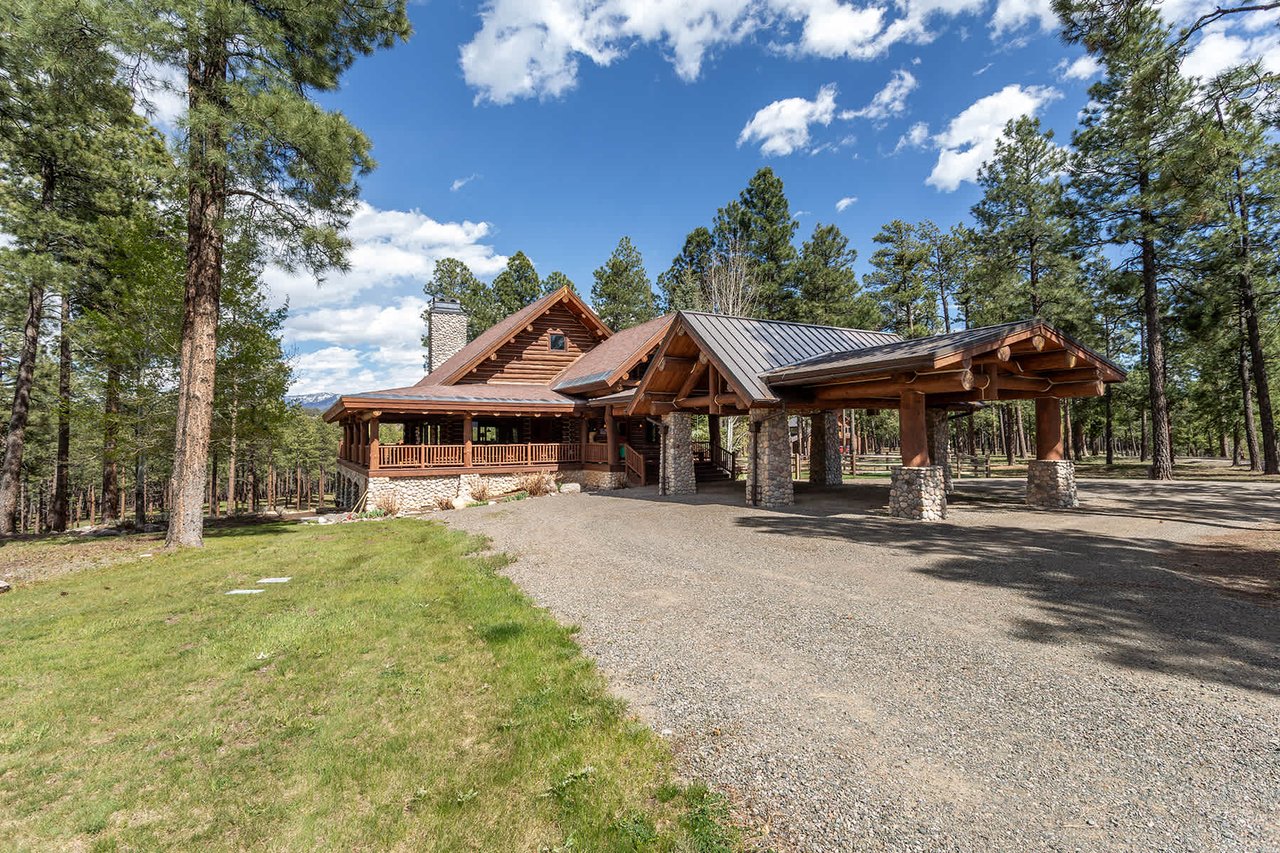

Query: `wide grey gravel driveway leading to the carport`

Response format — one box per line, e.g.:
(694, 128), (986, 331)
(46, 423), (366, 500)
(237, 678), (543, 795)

(449, 480), (1280, 850)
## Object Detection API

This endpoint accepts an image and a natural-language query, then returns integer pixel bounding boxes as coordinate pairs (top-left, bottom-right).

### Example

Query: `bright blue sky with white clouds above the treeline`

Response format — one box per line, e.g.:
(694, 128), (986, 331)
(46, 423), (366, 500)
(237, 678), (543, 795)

(249, 0), (1280, 393)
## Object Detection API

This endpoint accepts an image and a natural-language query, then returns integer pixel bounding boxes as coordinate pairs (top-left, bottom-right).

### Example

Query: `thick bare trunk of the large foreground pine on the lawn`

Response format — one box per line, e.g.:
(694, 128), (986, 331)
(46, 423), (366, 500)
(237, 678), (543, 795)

(165, 46), (228, 548)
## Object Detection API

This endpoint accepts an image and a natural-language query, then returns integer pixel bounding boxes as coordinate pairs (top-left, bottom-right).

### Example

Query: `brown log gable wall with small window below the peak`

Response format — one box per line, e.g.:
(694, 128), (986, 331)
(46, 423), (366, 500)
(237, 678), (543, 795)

(458, 305), (599, 386)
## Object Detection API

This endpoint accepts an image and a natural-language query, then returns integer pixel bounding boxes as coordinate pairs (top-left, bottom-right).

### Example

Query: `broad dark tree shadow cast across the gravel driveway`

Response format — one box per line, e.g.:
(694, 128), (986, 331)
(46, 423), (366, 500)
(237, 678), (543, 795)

(736, 504), (1280, 695)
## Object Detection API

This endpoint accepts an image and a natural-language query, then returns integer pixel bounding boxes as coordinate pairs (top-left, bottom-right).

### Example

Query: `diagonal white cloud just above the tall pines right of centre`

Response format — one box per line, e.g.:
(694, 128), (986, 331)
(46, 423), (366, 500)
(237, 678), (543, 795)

(925, 83), (1062, 192)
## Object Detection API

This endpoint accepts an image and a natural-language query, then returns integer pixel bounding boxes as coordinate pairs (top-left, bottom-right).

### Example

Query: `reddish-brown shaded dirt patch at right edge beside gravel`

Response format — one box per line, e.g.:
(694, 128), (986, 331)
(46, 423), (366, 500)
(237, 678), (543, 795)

(1169, 529), (1280, 607)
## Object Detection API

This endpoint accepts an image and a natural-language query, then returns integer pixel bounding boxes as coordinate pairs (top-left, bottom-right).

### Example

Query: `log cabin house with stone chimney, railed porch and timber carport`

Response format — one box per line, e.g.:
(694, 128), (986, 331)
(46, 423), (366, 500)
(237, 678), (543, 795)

(324, 288), (1125, 519)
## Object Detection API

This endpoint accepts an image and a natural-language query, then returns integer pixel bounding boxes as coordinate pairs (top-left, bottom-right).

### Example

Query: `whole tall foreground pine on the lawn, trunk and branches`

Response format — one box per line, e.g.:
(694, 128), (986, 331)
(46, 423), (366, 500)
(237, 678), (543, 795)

(119, 0), (410, 547)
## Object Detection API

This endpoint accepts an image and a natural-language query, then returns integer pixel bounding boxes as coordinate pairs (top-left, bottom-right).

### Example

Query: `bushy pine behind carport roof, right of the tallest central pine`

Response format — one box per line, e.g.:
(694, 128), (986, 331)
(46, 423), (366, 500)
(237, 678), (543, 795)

(794, 223), (882, 329)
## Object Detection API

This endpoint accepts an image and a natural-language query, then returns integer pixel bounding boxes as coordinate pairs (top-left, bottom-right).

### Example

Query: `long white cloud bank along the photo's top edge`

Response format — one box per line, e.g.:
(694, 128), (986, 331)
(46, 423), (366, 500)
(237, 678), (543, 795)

(458, 0), (988, 104)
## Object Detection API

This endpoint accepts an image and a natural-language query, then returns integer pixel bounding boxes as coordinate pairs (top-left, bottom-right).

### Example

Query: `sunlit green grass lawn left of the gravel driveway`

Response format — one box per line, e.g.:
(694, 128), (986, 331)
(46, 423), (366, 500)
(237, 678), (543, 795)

(0, 520), (740, 850)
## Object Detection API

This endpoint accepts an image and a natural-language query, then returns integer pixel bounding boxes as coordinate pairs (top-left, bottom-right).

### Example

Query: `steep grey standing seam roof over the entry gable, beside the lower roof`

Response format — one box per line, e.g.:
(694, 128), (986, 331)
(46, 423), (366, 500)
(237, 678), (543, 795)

(680, 311), (901, 401)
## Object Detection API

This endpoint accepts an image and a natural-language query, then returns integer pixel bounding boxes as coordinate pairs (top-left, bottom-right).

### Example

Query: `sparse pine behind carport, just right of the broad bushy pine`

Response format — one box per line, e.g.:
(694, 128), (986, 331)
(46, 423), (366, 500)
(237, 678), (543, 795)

(863, 219), (937, 338)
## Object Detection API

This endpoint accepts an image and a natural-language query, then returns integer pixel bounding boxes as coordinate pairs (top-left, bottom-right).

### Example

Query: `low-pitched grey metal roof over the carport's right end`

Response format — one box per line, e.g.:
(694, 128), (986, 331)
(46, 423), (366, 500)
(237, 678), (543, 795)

(763, 320), (1124, 386)
